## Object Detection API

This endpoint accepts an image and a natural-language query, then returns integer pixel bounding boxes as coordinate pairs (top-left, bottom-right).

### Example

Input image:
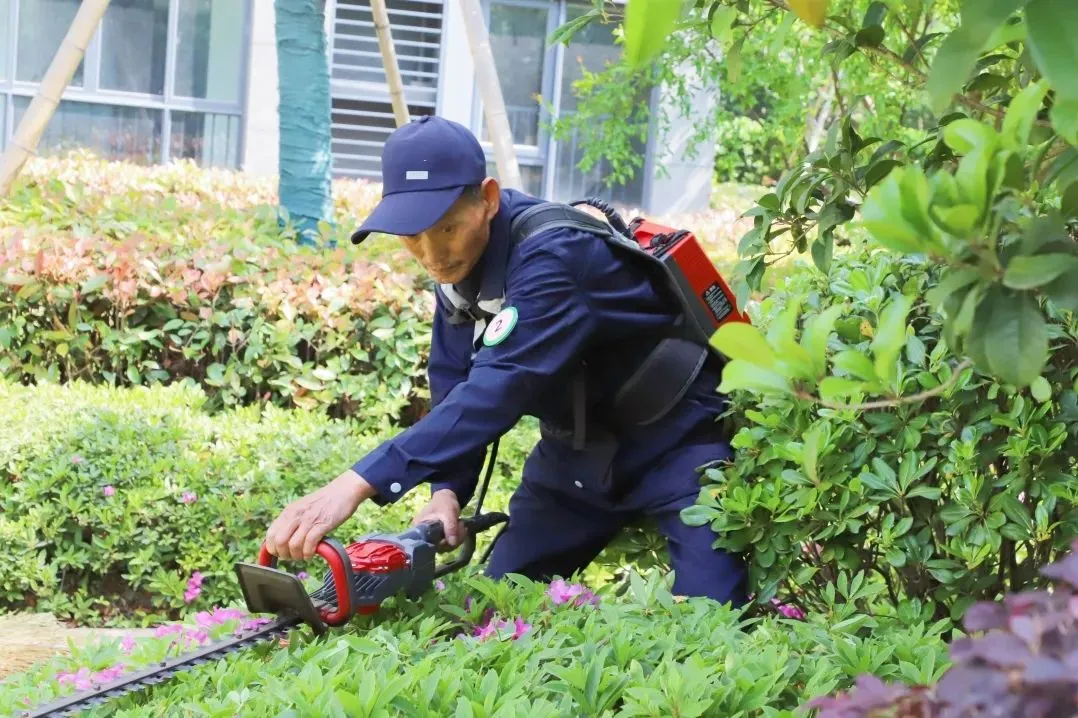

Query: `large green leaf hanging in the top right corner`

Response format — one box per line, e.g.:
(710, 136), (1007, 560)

(1025, 0), (1078, 100)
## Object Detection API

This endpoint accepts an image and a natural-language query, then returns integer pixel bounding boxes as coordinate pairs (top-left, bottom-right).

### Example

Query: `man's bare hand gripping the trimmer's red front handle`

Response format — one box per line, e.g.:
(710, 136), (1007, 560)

(266, 469), (376, 560)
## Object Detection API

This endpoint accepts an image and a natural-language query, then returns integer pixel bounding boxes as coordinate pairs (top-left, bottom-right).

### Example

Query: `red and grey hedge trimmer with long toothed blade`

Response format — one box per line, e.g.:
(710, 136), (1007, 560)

(15, 508), (509, 718)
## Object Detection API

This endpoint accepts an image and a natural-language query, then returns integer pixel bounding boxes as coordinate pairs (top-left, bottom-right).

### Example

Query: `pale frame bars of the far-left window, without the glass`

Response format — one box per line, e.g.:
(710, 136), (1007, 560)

(0, 0), (253, 169)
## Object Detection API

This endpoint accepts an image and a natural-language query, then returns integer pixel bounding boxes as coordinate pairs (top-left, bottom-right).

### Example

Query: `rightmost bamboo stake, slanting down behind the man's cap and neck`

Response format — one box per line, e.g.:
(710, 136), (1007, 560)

(459, 0), (523, 190)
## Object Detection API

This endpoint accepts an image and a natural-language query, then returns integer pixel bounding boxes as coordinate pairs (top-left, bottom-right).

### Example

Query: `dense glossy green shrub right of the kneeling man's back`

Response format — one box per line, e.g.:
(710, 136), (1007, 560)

(685, 244), (1078, 619)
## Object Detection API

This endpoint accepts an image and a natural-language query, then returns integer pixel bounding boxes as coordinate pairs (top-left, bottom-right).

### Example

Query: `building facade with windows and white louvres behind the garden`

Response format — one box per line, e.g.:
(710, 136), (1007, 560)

(6, 0), (713, 212)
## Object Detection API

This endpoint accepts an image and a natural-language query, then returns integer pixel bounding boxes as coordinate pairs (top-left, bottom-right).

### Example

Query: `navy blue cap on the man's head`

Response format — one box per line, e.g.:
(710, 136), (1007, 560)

(351, 115), (486, 245)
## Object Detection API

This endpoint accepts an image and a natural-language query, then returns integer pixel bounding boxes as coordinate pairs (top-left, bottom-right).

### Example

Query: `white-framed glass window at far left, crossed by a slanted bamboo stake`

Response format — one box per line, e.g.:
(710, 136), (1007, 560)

(0, 0), (251, 168)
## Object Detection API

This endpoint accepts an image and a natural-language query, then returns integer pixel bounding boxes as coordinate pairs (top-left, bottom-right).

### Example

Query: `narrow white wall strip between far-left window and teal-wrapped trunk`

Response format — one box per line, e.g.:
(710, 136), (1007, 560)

(240, 0), (279, 175)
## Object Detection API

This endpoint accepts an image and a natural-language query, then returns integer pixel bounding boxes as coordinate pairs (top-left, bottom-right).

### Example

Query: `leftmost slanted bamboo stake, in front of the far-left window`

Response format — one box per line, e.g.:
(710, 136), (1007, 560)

(0, 0), (109, 197)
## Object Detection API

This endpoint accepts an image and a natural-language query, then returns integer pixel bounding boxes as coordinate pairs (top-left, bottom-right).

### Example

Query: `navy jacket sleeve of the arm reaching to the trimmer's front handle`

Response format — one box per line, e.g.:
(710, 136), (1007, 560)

(353, 241), (598, 505)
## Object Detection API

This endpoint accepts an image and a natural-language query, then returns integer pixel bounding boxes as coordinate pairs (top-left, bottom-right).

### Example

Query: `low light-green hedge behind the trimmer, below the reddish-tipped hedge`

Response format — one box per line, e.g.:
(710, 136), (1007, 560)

(0, 382), (547, 623)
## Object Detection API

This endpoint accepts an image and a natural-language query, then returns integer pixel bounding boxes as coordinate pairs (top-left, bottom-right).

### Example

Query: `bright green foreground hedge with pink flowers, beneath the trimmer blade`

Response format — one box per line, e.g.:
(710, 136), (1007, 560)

(0, 574), (946, 718)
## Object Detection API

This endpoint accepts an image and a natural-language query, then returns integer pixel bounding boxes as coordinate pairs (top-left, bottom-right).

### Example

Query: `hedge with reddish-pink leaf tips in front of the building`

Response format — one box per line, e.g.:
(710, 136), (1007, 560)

(0, 153), (433, 424)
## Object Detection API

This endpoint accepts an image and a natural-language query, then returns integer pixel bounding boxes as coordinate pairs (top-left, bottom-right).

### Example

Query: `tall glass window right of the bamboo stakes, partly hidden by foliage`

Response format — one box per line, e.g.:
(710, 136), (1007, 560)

(472, 0), (652, 207)
